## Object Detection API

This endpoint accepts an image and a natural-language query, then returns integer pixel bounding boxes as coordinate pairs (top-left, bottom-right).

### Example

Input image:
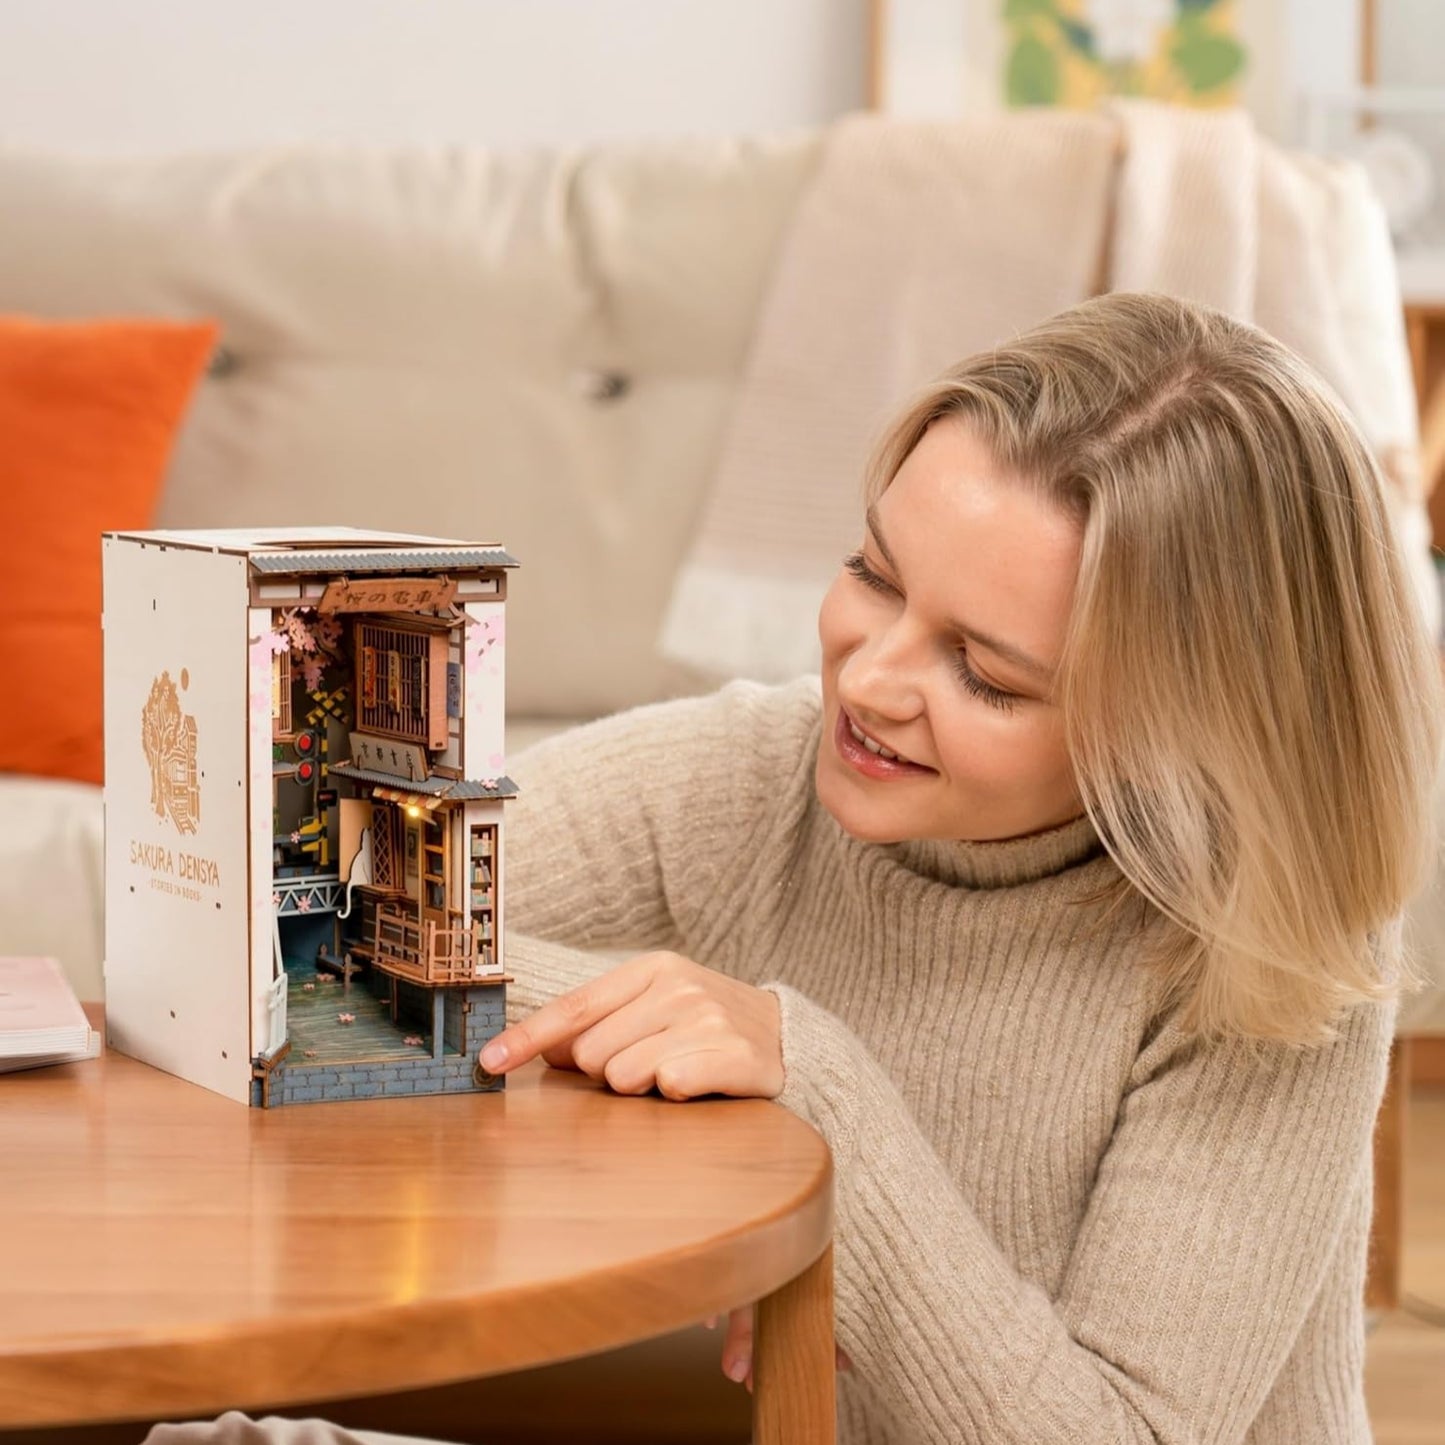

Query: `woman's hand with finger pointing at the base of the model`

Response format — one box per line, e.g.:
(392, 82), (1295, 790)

(481, 954), (783, 1100)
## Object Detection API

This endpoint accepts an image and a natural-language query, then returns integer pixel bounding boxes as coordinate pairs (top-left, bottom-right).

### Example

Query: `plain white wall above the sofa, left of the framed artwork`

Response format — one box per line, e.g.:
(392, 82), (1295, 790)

(0, 0), (867, 155)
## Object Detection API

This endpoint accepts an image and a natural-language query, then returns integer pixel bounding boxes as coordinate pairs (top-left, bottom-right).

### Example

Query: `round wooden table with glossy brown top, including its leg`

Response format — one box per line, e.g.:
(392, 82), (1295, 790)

(0, 1055), (834, 1445)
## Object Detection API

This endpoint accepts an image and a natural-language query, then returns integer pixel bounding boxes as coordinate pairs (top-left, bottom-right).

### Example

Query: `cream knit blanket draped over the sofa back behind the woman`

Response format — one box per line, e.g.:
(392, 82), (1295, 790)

(660, 103), (1439, 681)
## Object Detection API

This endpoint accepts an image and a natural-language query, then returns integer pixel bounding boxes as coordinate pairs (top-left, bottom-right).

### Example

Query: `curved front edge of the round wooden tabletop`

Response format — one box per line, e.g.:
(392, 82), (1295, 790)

(0, 1105), (834, 1429)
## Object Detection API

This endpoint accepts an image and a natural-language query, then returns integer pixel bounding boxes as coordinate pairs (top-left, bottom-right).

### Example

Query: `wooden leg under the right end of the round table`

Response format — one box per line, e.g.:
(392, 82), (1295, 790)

(753, 1244), (838, 1445)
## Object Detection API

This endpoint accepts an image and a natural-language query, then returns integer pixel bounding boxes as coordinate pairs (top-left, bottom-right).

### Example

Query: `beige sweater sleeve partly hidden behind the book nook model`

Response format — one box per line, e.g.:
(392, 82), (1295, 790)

(503, 679), (816, 1017)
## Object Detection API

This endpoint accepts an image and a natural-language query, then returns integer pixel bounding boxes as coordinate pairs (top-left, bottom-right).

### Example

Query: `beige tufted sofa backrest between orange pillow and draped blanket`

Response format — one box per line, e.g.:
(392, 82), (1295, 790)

(0, 133), (818, 715)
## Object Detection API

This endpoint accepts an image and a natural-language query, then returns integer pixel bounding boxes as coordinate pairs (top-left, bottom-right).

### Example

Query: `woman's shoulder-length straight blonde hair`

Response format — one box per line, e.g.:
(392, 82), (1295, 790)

(868, 295), (1439, 1043)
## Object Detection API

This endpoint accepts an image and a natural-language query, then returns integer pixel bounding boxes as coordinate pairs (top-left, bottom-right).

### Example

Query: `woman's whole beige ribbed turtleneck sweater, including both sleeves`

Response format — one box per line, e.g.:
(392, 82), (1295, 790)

(506, 681), (1392, 1445)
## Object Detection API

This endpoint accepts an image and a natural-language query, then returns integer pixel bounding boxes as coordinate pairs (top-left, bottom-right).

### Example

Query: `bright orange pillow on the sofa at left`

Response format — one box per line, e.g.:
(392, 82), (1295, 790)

(0, 315), (218, 783)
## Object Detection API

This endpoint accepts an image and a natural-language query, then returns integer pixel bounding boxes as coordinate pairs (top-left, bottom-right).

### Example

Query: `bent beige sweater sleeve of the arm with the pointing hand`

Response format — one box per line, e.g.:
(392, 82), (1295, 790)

(766, 984), (1392, 1445)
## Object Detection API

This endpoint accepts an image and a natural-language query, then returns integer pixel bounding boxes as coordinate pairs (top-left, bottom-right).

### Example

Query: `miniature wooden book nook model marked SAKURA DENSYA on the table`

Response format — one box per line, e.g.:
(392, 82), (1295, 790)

(104, 527), (516, 1107)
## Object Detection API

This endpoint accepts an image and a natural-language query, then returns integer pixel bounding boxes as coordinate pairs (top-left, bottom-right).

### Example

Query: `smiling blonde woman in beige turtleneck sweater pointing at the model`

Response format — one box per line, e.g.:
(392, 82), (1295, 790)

(484, 295), (1438, 1445)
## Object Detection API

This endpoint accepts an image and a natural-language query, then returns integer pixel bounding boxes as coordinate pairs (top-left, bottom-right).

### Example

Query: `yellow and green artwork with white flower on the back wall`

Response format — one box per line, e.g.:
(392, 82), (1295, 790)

(997, 0), (1247, 107)
